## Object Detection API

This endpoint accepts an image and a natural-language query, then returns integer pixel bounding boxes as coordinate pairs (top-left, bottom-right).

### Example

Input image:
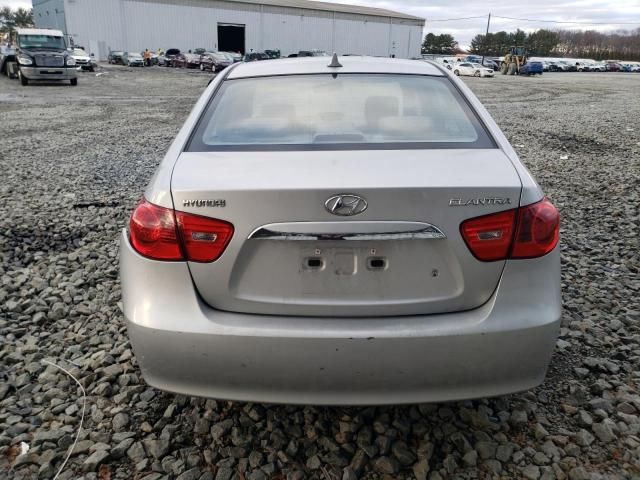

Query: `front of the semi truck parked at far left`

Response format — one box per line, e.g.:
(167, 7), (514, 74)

(16, 28), (78, 85)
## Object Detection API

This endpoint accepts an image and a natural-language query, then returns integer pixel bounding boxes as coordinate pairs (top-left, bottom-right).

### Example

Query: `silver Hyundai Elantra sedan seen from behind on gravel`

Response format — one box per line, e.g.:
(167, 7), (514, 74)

(119, 57), (562, 405)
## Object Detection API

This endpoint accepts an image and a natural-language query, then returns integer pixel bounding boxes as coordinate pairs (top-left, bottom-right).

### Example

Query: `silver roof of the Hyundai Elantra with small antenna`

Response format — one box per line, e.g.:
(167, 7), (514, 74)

(227, 56), (445, 79)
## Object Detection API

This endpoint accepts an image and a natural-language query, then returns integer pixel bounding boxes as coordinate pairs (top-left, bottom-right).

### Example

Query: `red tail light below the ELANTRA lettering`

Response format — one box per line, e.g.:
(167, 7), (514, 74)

(460, 198), (560, 262)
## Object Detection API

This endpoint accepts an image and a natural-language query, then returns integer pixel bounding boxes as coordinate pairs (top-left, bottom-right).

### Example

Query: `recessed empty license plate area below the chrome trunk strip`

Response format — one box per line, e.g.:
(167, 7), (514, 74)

(229, 240), (463, 306)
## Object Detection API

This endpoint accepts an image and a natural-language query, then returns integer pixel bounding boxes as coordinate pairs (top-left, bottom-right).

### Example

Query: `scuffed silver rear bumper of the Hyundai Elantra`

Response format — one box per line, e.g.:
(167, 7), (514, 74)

(120, 232), (561, 405)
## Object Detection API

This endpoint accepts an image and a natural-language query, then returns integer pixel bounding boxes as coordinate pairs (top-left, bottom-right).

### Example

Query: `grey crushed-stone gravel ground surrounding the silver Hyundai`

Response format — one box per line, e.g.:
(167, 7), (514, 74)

(0, 67), (640, 480)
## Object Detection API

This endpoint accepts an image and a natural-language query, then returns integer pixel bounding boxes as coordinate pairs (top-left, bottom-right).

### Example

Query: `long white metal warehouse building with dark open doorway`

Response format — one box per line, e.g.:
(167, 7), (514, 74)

(33, 0), (424, 60)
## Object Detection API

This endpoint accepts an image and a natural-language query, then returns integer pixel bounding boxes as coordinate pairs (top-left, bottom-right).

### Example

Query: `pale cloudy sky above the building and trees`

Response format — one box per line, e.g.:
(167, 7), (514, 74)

(0, 0), (640, 47)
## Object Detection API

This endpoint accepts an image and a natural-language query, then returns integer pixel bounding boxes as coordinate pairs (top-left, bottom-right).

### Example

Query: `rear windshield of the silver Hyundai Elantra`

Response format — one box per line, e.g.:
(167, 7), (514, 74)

(187, 74), (495, 152)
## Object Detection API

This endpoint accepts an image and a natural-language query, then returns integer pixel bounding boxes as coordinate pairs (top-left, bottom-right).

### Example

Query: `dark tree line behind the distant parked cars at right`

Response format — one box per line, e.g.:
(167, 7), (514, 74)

(422, 28), (640, 60)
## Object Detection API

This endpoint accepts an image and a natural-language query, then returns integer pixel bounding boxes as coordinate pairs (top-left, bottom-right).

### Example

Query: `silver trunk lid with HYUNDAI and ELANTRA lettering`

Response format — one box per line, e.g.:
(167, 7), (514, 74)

(172, 149), (521, 317)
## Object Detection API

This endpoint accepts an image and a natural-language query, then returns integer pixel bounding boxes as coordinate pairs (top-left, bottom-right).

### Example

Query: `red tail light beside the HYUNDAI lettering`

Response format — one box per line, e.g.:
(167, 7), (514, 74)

(129, 200), (233, 262)
